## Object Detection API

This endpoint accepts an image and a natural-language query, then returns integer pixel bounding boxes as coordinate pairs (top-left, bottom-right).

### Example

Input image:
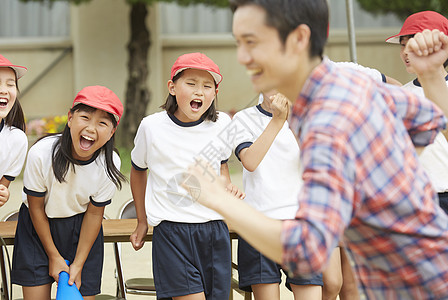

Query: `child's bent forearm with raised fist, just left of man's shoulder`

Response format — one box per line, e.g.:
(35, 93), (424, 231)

(239, 94), (289, 172)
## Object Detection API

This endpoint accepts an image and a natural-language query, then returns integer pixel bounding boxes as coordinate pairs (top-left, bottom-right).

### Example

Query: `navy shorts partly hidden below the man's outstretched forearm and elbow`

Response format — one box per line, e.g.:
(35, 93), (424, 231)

(238, 238), (323, 292)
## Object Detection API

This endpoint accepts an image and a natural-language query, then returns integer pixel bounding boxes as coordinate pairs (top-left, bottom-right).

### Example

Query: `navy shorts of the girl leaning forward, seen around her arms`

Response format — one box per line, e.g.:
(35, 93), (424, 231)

(11, 204), (104, 296)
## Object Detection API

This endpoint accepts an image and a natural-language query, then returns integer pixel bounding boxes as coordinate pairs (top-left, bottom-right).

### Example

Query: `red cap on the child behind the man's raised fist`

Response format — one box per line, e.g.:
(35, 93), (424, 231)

(386, 10), (448, 44)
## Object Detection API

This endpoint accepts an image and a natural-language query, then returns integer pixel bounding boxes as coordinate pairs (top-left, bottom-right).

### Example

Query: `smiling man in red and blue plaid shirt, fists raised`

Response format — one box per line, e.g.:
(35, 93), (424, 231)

(181, 0), (448, 299)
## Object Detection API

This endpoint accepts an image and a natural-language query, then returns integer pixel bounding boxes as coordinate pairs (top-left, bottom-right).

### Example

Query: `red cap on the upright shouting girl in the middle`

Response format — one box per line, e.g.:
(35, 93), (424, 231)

(171, 52), (222, 87)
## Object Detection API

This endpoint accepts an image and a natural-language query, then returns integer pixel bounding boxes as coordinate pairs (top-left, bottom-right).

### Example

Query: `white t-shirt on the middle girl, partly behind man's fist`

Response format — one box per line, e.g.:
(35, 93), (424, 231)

(131, 111), (232, 226)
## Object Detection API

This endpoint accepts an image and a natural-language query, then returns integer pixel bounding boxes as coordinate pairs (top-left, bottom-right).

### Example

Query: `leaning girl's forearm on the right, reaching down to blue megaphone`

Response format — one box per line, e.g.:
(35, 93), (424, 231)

(68, 203), (104, 289)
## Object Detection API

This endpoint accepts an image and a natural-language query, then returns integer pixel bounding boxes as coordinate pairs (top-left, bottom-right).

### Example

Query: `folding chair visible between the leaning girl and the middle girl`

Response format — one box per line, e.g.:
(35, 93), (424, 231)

(114, 199), (156, 299)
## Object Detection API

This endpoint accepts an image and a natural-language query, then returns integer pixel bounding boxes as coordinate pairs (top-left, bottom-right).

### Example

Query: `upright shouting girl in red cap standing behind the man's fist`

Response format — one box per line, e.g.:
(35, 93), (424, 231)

(131, 53), (242, 300)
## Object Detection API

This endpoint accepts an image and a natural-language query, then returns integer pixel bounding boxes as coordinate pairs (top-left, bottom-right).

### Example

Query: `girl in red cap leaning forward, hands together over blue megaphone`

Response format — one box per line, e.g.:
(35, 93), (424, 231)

(11, 86), (125, 300)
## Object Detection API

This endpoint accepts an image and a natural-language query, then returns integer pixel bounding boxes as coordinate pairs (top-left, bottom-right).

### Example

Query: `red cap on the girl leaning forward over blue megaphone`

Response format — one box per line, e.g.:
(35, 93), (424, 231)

(72, 85), (123, 125)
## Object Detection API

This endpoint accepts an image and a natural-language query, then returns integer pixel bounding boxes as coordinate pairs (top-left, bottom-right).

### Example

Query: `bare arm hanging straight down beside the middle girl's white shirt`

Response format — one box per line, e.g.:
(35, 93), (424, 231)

(130, 166), (148, 250)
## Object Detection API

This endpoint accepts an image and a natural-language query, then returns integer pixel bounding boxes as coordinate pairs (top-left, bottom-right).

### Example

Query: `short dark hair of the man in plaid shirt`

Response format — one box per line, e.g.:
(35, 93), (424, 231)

(229, 0), (328, 57)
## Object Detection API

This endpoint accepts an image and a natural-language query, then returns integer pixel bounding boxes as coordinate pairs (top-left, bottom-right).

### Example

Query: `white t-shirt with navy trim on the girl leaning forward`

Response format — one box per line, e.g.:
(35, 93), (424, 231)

(23, 135), (121, 218)
